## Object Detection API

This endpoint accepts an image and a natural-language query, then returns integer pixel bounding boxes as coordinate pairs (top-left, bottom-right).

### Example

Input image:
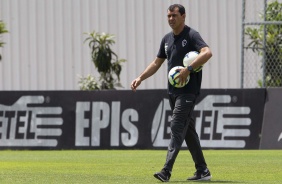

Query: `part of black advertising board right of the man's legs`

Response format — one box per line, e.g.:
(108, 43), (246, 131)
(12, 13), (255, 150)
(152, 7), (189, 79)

(195, 89), (265, 149)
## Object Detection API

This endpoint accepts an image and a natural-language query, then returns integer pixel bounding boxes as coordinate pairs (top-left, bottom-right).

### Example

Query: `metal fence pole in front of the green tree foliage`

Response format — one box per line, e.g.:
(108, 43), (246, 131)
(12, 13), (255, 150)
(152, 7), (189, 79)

(262, 0), (267, 88)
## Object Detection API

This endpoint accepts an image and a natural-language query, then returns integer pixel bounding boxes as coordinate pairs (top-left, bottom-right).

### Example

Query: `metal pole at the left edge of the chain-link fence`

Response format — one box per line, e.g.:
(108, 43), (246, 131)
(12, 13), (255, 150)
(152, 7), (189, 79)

(241, 0), (246, 88)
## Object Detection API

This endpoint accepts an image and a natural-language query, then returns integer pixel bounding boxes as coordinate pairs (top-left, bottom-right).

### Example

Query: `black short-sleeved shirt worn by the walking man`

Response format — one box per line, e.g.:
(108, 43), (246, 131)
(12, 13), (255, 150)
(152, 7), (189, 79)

(157, 26), (208, 95)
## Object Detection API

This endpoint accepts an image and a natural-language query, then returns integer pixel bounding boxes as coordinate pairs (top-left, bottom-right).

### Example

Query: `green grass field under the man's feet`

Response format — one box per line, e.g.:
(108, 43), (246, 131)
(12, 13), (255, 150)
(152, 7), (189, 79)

(0, 150), (282, 184)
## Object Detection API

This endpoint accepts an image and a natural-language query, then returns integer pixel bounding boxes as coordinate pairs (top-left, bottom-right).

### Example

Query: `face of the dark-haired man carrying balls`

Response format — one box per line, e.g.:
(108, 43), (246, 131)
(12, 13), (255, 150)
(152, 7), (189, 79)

(167, 7), (185, 29)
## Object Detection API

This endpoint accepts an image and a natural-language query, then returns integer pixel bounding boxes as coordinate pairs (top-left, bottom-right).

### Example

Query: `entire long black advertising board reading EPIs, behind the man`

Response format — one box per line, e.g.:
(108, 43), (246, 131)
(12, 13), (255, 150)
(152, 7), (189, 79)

(0, 89), (265, 149)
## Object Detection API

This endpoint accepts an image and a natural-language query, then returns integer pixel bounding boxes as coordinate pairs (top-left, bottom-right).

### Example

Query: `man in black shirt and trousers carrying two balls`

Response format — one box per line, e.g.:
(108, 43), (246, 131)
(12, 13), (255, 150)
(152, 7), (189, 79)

(131, 4), (212, 182)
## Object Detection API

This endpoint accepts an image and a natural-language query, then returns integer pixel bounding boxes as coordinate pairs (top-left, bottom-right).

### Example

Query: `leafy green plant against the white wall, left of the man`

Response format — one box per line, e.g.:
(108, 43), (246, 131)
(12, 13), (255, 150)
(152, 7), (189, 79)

(79, 31), (126, 90)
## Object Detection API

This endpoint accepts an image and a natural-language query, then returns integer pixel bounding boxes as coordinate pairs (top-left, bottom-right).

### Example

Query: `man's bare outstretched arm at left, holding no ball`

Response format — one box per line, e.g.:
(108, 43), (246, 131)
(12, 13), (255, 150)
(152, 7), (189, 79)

(131, 57), (165, 91)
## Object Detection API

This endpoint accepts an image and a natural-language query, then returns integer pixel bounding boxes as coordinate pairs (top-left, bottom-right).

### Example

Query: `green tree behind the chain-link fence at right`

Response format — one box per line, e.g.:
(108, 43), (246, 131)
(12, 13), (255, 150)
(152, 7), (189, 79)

(245, 1), (282, 87)
